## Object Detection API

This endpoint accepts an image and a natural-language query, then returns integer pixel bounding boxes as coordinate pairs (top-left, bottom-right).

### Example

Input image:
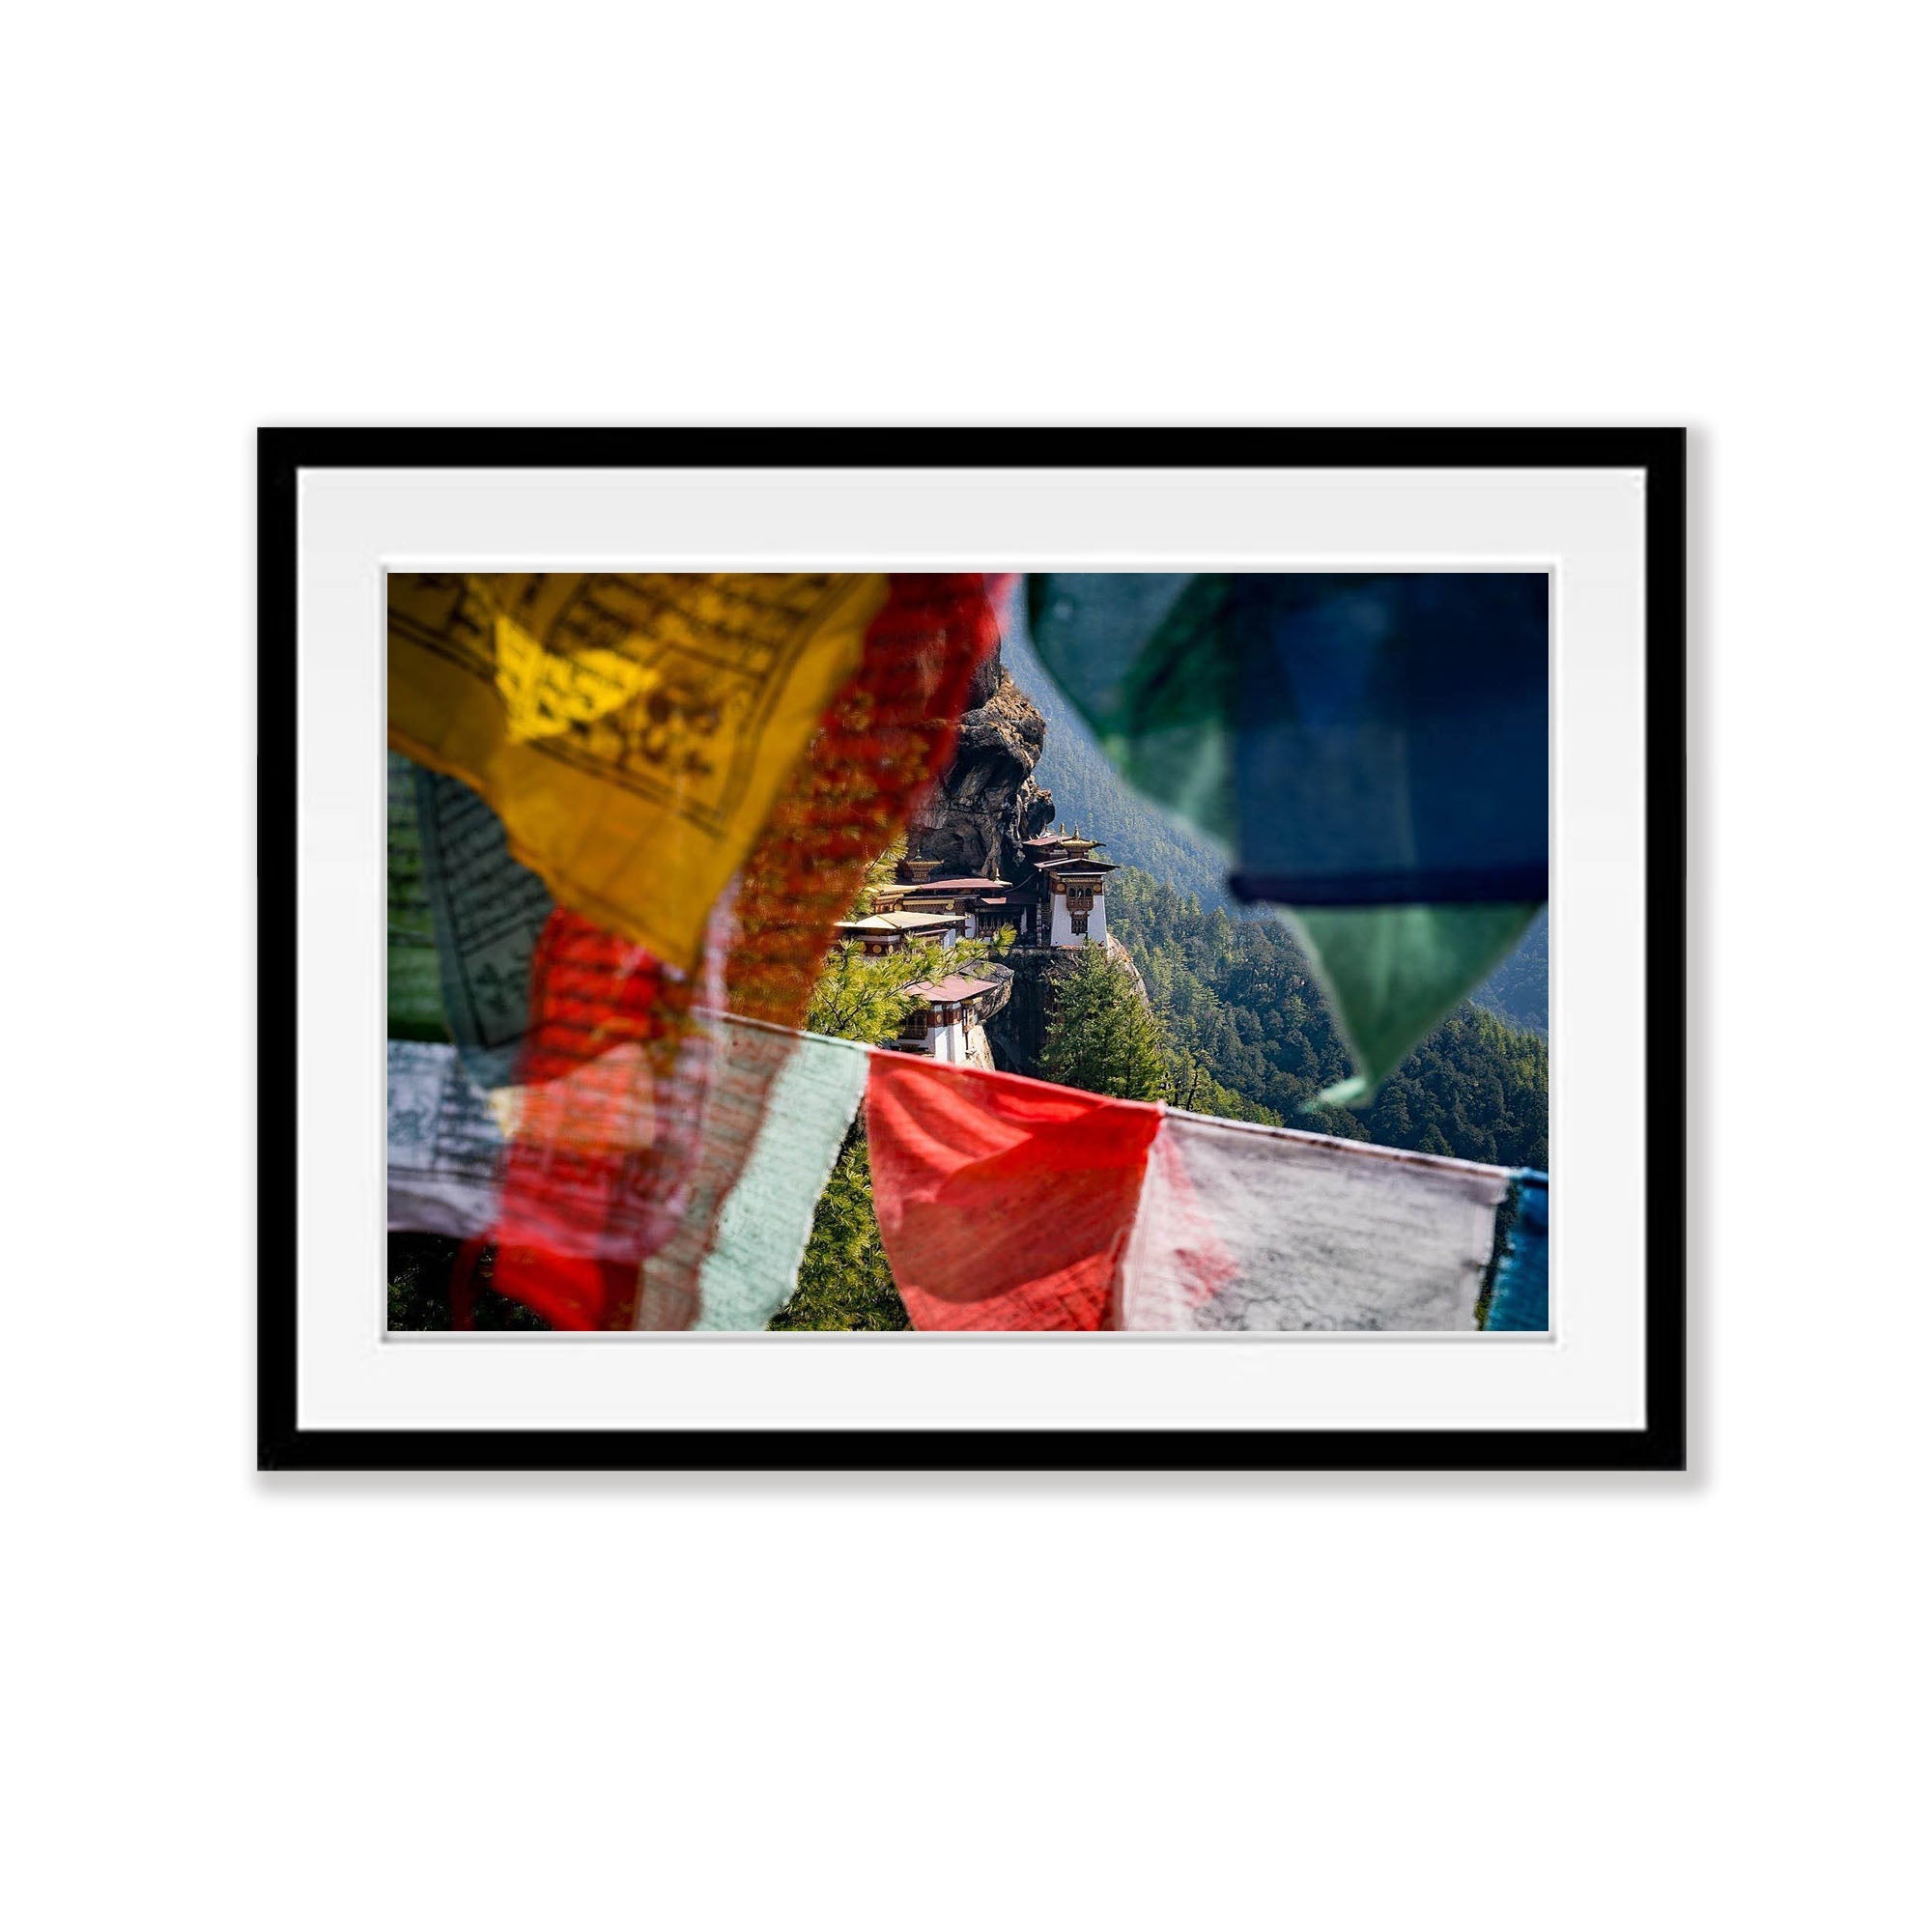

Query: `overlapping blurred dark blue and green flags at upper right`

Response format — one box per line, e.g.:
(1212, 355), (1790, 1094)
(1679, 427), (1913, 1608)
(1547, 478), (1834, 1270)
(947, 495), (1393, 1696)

(1030, 572), (1549, 1105)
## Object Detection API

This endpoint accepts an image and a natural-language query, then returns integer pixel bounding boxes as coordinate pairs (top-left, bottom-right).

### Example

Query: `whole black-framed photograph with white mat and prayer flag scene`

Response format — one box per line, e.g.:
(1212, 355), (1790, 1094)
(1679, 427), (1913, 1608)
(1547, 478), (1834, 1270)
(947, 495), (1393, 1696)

(259, 429), (1685, 1470)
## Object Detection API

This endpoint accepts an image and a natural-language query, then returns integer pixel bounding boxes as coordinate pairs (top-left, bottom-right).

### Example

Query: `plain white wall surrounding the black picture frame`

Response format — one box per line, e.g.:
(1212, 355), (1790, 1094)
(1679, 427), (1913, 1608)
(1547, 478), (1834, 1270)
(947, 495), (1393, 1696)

(0, 0), (1932, 1932)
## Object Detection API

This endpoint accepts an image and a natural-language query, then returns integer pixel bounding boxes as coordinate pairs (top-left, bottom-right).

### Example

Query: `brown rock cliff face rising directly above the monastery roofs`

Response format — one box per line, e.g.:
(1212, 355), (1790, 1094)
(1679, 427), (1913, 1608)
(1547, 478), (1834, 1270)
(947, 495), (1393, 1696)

(906, 657), (1053, 885)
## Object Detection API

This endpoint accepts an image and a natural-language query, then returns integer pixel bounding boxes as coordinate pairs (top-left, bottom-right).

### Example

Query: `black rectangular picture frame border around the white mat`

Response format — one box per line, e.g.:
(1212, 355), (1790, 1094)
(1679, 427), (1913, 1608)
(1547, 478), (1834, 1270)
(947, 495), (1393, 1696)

(257, 429), (1687, 1470)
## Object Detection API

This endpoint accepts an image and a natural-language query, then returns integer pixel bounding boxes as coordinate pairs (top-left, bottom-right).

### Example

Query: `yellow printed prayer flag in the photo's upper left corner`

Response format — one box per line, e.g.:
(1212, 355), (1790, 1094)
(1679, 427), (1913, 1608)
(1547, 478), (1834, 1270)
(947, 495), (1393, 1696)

(388, 574), (887, 970)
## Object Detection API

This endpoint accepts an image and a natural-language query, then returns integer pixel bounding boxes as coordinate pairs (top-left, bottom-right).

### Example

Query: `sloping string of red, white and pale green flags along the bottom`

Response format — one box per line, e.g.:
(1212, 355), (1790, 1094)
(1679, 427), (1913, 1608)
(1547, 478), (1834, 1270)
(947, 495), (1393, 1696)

(388, 1014), (1549, 1333)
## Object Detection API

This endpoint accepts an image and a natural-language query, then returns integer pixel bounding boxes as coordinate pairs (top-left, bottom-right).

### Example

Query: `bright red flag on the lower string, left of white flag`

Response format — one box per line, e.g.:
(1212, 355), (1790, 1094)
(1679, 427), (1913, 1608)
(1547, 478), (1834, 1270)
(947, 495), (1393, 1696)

(866, 1053), (1161, 1329)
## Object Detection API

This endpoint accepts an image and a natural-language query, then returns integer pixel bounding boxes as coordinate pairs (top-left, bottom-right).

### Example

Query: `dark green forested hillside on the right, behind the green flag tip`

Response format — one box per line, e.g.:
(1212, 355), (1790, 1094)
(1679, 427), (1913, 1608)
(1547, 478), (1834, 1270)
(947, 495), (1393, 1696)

(1107, 867), (1549, 1167)
